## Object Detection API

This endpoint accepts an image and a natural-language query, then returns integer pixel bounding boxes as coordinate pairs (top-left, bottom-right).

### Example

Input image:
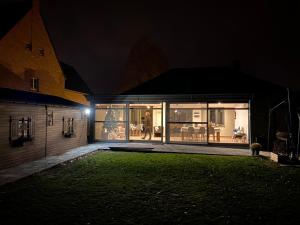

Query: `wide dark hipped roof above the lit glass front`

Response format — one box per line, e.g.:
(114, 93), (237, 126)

(123, 67), (284, 95)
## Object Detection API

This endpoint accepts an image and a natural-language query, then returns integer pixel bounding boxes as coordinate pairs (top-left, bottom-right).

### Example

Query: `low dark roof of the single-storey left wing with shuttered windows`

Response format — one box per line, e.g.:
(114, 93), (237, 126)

(0, 88), (84, 106)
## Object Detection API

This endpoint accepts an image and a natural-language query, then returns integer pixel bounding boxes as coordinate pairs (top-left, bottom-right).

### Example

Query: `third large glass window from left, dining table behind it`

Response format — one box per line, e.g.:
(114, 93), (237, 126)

(168, 103), (207, 143)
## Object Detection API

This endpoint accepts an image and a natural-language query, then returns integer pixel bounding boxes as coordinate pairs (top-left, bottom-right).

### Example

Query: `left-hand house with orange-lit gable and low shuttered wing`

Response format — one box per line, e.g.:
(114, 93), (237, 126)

(0, 0), (90, 169)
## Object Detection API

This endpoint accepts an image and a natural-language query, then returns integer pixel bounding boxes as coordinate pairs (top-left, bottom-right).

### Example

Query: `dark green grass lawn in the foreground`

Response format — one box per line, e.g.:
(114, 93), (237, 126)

(0, 152), (300, 225)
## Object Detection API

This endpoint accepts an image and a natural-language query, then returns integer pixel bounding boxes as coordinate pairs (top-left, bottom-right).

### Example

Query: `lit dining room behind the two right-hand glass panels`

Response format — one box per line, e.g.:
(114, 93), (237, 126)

(169, 103), (249, 144)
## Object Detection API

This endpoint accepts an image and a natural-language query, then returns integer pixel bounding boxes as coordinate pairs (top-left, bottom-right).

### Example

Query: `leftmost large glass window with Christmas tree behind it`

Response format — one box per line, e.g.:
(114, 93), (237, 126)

(95, 104), (126, 140)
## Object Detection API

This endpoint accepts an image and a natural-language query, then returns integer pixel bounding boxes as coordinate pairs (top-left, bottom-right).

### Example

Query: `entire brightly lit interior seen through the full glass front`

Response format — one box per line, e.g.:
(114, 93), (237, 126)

(95, 102), (249, 144)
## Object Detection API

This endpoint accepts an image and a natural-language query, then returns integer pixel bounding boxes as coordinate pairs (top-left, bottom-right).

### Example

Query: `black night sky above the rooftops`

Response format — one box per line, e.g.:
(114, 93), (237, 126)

(5, 0), (300, 93)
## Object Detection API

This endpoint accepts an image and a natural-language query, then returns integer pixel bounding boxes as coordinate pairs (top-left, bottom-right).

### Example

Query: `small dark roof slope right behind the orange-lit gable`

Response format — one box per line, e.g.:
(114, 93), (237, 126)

(60, 62), (91, 94)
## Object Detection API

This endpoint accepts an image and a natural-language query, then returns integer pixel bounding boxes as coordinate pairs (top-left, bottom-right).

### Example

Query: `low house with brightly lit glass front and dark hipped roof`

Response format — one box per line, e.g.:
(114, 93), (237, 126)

(92, 64), (286, 147)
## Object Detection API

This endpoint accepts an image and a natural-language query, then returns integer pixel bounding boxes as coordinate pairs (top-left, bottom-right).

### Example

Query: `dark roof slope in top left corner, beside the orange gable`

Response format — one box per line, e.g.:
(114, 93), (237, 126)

(0, 0), (32, 39)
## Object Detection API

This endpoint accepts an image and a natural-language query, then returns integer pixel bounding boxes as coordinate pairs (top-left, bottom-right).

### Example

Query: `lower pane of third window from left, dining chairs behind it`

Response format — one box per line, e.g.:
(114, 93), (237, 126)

(169, 123), (207, 143)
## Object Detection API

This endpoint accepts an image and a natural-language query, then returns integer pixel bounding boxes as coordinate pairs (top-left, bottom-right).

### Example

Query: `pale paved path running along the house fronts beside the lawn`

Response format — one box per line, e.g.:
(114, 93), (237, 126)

(0, 143), (251, 185)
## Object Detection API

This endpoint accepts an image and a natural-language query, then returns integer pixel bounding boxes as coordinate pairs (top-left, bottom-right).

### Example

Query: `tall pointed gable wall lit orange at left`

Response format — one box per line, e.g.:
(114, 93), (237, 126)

(0, 2), (64, 95)
